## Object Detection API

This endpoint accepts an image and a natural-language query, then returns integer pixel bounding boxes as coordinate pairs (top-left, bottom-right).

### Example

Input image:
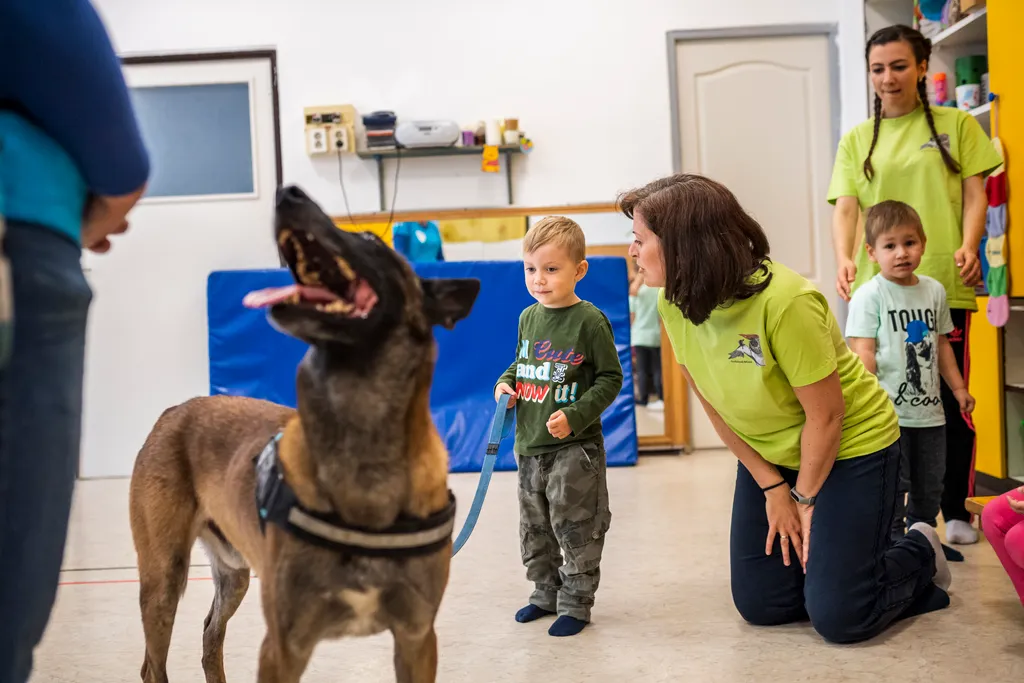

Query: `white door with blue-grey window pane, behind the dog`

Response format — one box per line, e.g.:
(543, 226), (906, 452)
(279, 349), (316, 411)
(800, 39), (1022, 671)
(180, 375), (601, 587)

(80, 57), (280, 477)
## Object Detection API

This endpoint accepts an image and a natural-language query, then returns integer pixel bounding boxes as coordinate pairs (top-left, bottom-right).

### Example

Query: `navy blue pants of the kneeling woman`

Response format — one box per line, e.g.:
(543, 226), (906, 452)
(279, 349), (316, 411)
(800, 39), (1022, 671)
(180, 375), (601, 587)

(730, 441), (949, 643)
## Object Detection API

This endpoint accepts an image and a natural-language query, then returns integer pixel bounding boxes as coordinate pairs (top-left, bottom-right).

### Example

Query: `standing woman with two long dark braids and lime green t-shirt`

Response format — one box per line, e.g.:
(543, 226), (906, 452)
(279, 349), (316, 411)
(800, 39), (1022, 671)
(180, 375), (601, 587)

(828, 25), (1001, 544)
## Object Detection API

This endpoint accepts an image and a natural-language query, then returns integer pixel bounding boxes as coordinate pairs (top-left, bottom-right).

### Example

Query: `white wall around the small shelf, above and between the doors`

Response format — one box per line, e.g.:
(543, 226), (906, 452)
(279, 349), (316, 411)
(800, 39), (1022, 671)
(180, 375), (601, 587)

(94, 0), (866, 225)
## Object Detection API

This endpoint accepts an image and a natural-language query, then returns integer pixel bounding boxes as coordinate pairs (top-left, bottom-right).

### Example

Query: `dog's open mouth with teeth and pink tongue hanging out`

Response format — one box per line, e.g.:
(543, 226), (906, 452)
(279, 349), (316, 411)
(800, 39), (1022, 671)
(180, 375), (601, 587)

(243, 230), (377, 318)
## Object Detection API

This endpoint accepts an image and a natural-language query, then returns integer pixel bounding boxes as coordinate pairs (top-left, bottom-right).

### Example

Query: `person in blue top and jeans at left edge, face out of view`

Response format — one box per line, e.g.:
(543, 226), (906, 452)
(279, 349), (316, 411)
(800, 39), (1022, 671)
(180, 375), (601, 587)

(0, 0), (150, 683)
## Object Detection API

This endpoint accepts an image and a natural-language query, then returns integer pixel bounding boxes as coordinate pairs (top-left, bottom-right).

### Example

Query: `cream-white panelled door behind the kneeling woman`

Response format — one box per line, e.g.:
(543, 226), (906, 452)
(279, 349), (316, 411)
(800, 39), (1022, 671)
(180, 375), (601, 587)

(675, 34), (841, 449)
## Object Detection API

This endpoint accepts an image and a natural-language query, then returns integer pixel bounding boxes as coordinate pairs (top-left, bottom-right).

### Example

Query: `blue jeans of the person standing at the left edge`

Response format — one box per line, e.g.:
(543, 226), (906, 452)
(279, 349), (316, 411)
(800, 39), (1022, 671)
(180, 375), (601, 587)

(0, 222), (92, 683)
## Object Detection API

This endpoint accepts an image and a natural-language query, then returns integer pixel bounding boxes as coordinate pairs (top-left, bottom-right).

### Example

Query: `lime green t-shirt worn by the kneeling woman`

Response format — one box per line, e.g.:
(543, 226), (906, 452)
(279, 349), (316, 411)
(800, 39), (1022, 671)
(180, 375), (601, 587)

(658, 263), (899, 469)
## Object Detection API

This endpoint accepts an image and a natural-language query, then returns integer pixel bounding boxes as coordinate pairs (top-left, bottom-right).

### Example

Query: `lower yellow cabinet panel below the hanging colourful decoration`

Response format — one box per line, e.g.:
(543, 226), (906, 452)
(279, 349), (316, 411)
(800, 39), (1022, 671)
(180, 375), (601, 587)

(968, 299), (1007, 478)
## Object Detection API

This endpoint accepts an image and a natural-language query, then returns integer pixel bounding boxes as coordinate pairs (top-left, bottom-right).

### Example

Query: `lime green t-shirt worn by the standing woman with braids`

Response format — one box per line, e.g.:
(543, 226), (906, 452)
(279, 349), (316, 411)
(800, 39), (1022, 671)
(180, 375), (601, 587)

(828, 105), (1002, 310)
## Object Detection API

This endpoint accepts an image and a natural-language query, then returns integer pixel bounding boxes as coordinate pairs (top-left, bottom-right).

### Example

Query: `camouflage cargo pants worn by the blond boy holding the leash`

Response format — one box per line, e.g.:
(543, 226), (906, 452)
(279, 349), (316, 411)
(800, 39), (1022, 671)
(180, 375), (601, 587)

(518, 443), (611, 622)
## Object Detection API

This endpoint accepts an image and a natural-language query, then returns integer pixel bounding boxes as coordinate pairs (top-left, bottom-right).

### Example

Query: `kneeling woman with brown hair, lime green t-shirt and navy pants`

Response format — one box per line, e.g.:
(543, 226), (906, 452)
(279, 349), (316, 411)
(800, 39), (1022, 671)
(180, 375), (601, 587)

(620, 174), (950, 643)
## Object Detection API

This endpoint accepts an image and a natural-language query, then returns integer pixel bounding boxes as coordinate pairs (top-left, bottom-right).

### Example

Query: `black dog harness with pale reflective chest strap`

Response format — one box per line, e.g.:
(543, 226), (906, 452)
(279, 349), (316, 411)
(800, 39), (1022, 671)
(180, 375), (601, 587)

(256, 432), (455, 557)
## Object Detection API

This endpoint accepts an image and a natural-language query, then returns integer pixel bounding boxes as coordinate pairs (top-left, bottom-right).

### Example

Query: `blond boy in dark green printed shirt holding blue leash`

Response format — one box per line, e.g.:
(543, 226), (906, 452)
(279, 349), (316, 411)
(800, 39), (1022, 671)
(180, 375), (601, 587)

(495, 216), (623, 636)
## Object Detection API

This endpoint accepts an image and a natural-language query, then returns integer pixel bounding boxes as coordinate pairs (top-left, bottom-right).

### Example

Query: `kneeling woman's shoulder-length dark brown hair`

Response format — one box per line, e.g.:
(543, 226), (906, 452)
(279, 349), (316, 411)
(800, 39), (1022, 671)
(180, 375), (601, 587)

(618, 173), (771, 325)
